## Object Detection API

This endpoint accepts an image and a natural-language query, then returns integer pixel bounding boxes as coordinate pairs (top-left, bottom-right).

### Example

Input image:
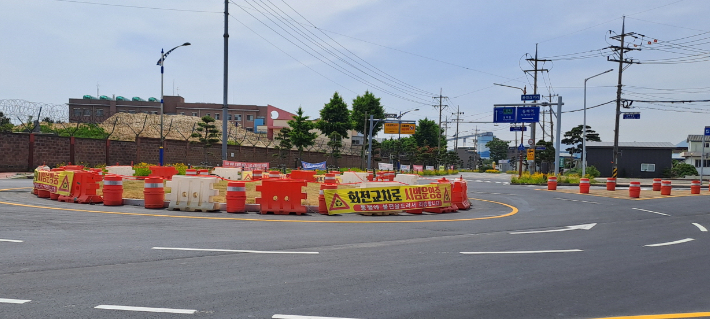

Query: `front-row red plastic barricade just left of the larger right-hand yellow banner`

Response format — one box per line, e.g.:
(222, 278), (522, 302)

(255, 179), (308, 215)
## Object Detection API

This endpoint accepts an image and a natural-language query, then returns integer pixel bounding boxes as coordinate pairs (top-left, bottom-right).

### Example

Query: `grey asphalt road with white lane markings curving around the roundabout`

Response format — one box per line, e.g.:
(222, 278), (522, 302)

(0, 173), (710, 318)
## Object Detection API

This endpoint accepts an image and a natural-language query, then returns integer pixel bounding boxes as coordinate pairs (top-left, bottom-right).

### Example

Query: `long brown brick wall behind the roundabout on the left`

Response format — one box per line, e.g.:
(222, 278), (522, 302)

(0, 133), (377, 172)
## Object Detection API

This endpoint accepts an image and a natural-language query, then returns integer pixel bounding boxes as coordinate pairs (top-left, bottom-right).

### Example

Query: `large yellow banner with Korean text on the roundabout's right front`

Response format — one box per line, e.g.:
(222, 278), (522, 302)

(323, 184), (451, 215)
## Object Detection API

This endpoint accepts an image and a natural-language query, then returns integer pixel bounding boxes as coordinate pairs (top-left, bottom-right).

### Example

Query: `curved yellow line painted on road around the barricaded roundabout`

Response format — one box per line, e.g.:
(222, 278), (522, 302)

(0, 187), (518, 224)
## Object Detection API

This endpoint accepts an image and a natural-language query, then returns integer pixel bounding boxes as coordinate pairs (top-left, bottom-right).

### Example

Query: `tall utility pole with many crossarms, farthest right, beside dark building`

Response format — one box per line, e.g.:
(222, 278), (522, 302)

(606, 16), (644, 178)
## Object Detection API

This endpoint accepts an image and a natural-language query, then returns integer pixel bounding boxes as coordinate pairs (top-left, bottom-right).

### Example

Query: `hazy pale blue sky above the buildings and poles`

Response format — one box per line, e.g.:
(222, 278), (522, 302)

(0, 0), (710, 147)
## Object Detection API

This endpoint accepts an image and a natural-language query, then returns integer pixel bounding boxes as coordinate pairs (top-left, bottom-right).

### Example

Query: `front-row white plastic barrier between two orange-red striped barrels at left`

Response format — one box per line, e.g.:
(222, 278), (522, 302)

(165, 175), (219, 212)
